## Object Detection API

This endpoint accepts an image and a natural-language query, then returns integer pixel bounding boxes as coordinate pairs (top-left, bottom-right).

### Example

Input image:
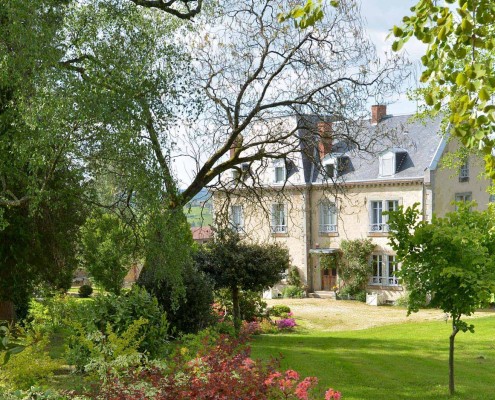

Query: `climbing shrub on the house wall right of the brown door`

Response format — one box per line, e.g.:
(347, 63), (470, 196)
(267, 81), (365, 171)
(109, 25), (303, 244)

(339, 239), (376, 296)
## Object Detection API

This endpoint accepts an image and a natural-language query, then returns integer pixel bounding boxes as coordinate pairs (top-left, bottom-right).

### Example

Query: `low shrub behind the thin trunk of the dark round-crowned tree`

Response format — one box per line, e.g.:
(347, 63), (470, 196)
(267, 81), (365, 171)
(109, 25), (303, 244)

(215, 289), (267, 322)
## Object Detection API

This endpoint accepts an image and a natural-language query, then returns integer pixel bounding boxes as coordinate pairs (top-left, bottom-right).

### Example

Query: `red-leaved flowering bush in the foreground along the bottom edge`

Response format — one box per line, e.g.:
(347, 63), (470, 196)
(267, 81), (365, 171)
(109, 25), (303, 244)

(92, 326), (340, 400)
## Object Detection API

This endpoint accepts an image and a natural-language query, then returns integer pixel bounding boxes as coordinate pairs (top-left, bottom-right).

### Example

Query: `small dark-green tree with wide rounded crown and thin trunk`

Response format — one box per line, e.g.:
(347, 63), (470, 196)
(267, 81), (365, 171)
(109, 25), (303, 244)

(196, 229), (290, 332)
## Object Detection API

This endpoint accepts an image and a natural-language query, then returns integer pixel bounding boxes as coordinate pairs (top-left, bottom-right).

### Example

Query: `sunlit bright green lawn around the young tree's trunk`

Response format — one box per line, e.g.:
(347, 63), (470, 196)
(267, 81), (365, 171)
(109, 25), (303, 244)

(252, 317), (495, 400)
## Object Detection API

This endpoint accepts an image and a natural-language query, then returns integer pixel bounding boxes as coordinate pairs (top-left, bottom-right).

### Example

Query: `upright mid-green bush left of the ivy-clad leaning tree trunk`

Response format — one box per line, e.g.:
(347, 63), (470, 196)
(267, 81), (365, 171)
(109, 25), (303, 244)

(80, 213), (135, 294)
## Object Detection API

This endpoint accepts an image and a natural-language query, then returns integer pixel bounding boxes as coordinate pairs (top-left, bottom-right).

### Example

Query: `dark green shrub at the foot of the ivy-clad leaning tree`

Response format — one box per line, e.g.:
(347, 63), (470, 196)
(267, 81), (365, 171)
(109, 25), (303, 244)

(138, 266), (215, 333)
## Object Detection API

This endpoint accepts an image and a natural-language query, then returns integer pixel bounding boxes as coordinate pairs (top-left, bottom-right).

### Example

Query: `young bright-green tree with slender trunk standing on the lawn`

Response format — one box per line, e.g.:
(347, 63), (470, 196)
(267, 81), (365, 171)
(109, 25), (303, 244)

(389, 203), (495, 394)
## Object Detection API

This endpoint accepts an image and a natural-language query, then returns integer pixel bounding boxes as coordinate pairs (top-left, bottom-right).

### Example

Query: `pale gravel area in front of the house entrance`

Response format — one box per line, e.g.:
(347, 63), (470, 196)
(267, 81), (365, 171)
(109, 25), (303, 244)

(265, 299), (495, 331)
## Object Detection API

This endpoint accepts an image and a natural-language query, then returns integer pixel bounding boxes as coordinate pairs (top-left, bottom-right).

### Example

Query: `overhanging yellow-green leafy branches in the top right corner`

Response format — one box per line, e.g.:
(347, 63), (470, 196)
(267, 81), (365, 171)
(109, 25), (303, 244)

(393, 0), (495, 179)
